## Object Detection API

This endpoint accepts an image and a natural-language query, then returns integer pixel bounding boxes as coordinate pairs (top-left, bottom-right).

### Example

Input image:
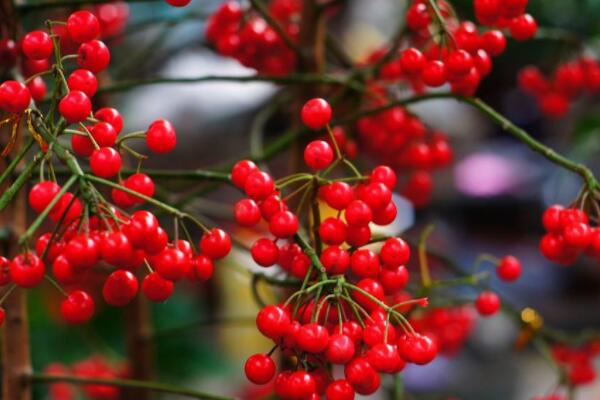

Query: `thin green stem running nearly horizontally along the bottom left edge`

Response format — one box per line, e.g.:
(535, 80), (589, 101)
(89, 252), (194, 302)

(28, 373), (232, 400)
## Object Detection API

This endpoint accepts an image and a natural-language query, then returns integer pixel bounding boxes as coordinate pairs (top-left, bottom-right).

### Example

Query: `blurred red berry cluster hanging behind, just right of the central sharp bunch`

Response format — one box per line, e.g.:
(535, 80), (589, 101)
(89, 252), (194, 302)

(357, 102), (452, 207)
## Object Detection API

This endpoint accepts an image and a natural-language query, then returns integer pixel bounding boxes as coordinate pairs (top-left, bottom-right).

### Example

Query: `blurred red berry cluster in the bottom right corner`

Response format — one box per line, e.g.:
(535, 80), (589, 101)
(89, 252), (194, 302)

(552, 341), (600, 386)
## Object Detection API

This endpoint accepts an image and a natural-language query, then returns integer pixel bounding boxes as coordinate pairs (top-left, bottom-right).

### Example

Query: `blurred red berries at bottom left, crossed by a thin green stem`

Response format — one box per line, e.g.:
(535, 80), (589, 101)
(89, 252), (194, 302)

(44, 355), (130, 400)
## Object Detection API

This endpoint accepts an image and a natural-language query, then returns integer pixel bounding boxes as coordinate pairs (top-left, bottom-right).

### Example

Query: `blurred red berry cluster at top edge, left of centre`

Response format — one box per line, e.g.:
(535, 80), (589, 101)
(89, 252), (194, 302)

(206, 0), (302, 75)
